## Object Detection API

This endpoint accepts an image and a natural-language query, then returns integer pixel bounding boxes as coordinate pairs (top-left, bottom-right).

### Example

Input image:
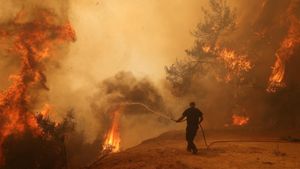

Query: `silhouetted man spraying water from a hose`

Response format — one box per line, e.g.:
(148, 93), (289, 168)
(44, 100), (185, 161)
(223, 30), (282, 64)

(176, 102), (203, 154)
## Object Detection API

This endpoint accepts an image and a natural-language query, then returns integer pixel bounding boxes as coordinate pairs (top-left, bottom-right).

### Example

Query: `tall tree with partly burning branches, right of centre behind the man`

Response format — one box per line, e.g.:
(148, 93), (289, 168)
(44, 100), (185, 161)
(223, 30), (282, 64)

(166, 0), (253, 126)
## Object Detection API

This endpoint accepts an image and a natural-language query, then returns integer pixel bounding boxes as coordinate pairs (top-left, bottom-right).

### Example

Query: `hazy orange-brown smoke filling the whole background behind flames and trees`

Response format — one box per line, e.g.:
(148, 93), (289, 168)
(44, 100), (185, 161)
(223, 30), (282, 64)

(0, 0), (300, 166)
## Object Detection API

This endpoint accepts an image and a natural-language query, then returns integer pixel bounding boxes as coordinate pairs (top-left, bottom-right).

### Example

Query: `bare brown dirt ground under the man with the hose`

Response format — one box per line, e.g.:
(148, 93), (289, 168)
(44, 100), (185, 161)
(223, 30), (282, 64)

(92, 129), (300, 169)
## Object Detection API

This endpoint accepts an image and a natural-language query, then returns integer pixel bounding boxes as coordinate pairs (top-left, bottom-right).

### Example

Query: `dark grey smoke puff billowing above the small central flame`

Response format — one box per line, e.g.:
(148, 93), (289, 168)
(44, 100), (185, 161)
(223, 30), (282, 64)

(92, 72), (165, 113)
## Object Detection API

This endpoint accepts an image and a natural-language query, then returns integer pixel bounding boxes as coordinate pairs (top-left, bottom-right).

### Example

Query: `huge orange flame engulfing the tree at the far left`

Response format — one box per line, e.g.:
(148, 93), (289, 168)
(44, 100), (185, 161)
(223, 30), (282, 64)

(0, 9), (75, 165)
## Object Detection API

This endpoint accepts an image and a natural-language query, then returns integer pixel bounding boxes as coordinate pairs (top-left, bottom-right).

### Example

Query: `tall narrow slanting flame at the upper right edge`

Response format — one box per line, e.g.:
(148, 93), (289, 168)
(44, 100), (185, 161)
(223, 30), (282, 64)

(267, 2), (300, 93)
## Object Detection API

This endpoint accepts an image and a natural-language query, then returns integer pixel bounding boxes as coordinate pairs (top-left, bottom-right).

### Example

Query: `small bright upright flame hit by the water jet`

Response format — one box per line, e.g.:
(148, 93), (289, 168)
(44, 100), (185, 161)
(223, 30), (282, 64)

(103, 109), (121, 152)
